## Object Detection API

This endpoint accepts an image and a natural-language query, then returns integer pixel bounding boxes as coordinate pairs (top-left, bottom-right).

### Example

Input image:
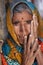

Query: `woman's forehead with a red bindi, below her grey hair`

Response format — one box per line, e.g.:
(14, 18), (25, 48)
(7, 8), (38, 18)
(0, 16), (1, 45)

(13, 11), (32, 20)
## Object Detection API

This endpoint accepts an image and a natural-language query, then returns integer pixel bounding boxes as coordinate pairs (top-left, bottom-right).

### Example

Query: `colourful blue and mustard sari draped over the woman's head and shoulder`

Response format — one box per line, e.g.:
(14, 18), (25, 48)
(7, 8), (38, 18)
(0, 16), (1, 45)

(2, 0), (42, 65)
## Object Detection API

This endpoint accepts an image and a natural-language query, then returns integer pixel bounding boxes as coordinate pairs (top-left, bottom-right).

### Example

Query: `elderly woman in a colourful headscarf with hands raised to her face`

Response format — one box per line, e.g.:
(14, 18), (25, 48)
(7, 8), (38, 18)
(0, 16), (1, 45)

(2, 1), (43, 65)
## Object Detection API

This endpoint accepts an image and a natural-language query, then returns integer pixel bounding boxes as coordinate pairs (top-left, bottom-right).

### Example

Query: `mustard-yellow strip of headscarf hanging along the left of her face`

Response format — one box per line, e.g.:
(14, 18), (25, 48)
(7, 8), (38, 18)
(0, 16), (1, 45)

(6, 8), (20, 45)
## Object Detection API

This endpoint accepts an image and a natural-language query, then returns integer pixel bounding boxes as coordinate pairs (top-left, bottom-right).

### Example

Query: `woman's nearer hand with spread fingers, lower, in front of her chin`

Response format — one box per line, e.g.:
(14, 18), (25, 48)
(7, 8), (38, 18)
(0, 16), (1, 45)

(23, 36), (38, 65)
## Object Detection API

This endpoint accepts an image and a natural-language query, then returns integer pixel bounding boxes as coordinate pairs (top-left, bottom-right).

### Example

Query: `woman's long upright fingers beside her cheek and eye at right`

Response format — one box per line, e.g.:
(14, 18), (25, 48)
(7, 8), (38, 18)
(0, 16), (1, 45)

(31, 14), (38, 44)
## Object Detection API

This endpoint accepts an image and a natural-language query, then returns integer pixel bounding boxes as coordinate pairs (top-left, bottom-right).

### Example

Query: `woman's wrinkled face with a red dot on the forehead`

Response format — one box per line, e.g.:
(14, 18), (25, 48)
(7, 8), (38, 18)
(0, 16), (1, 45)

(12, 11), (32, 44)
